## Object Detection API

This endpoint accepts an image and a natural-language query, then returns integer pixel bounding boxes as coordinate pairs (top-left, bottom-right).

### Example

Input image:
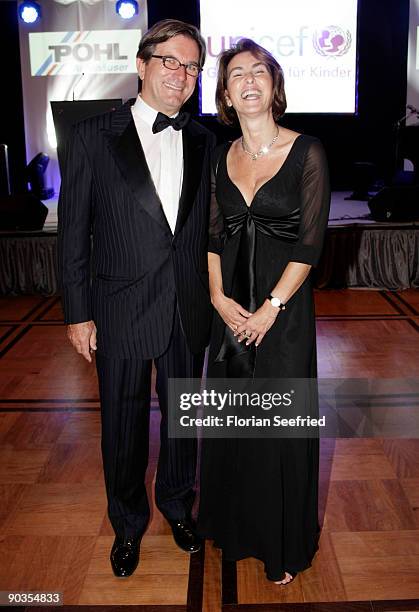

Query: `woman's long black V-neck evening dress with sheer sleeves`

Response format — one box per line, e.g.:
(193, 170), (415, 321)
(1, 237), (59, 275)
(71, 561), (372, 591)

(198, 135), (330, 580)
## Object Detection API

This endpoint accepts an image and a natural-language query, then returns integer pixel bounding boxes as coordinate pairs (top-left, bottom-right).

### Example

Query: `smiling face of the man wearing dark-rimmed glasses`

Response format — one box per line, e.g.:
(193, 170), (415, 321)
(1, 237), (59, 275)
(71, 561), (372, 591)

(137, 34), (199, 116)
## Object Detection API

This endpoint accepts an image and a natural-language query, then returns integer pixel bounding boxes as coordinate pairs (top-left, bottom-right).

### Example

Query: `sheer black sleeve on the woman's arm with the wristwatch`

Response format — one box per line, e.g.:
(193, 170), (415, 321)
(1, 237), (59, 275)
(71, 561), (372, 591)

(290, 139), (330, 266)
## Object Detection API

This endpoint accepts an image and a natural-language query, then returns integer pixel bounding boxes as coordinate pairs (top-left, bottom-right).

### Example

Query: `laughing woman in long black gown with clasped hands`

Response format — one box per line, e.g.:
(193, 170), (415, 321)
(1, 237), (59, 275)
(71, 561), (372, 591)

(198, 39), (330, 584)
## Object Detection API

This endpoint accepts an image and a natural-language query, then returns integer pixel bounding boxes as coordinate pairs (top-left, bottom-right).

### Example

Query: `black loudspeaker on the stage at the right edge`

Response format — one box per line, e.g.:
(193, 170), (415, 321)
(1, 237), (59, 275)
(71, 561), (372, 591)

(368, 186), (419, 221)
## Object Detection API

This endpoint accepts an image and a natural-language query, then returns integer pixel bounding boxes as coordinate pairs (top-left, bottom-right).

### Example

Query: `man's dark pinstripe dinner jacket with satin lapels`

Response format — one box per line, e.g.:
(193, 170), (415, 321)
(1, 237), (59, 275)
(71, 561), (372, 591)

(58, 101), (214, 359)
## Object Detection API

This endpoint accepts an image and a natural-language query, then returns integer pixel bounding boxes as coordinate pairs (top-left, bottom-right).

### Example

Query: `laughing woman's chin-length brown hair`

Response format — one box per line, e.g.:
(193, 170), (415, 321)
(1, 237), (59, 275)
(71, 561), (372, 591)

(215, 38), (287, 125)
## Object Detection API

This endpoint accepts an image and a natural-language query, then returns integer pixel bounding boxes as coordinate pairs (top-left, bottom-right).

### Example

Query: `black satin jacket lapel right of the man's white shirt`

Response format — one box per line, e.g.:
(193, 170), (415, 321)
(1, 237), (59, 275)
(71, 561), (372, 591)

(175, 124), (205, 235)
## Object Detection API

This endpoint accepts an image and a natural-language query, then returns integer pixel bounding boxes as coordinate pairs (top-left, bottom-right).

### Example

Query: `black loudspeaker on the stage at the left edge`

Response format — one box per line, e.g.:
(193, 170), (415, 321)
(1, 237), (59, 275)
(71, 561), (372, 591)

(0, 193), (48, 231)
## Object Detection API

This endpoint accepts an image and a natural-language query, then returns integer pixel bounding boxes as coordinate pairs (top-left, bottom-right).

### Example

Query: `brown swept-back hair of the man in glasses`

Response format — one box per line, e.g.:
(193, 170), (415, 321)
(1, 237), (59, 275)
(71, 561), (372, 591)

(137, 19), (206, 90)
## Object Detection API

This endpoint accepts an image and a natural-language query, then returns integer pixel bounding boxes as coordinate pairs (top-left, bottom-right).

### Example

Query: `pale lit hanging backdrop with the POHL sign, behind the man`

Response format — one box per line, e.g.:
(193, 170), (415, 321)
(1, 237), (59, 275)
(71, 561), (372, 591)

(19, 0), (147, 193)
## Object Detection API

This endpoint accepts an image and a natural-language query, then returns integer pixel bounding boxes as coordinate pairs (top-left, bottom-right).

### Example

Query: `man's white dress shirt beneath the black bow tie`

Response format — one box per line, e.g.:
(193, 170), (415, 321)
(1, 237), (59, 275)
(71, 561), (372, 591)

(131, 95), (183, 234)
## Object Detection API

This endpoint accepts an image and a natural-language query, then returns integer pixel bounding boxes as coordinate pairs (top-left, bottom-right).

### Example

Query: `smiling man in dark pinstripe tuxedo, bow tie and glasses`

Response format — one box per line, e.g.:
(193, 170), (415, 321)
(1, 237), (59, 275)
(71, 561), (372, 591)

(58, 19), (214, 576)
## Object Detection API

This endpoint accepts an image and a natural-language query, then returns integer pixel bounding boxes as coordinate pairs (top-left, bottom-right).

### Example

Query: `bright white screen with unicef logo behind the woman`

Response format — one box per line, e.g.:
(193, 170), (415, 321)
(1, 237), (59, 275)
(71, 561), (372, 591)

(201, 0), (358, 114)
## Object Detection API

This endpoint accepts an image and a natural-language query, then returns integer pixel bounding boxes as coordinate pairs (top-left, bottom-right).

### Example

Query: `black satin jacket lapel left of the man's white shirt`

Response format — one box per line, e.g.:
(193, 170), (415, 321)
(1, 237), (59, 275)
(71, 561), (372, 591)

(106, 103), (171, 233)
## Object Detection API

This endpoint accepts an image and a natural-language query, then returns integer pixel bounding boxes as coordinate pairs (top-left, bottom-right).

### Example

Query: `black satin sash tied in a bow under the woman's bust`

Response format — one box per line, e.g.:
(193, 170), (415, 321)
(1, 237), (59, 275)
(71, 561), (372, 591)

(215, 205), (300, 376)
